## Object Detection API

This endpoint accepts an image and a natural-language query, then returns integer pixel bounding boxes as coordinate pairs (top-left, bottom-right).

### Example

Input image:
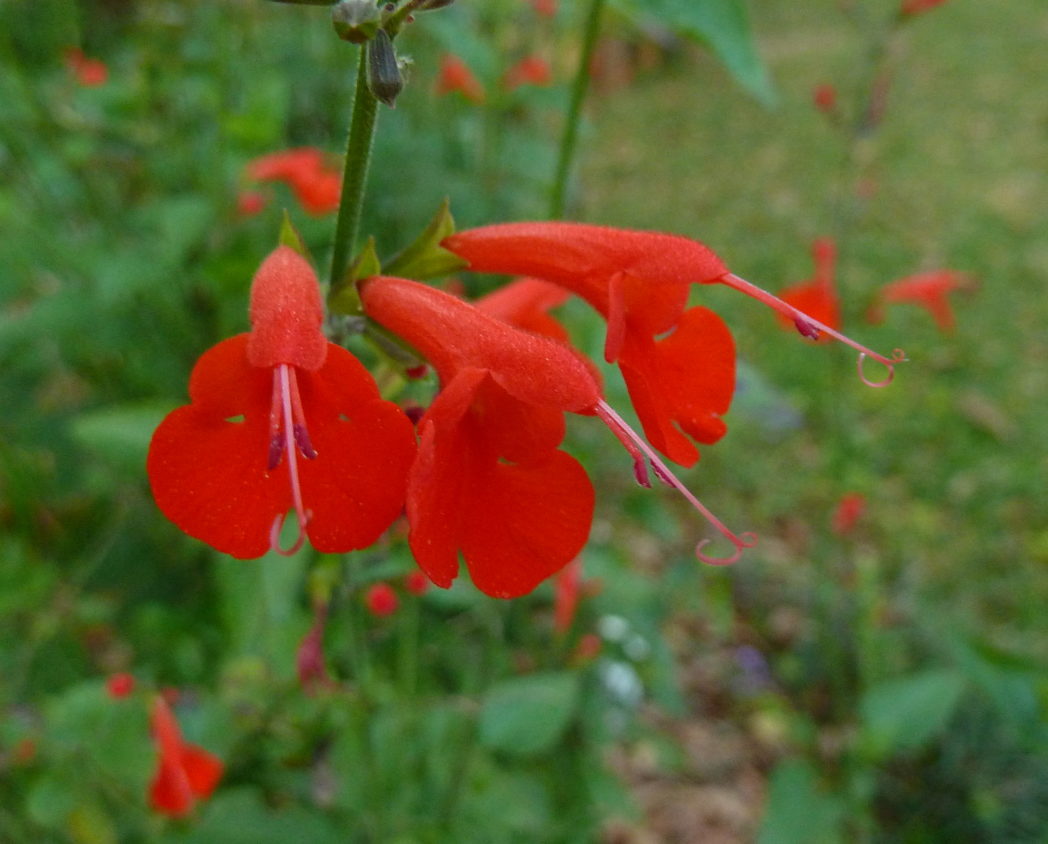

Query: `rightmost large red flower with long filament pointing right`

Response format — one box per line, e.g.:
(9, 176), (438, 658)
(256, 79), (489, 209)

(441, 221), (903, 466)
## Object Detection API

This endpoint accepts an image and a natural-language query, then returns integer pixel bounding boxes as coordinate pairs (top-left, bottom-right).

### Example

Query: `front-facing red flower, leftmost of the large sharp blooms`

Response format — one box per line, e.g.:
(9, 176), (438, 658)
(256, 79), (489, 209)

(147, 246), (415, 559)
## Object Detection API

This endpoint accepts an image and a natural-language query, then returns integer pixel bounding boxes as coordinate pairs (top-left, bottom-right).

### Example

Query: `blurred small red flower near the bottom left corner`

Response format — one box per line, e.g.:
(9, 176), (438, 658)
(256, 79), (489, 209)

(149, 695), (223, 818)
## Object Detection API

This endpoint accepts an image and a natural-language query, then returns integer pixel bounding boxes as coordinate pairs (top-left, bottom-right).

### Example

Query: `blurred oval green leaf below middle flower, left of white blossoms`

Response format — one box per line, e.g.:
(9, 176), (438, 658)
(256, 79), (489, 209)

(480, 672), (580, 756)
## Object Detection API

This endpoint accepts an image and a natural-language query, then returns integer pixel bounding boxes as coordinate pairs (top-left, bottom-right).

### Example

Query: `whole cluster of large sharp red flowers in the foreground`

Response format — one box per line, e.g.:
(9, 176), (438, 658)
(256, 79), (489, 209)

(148, 222), (902, 598)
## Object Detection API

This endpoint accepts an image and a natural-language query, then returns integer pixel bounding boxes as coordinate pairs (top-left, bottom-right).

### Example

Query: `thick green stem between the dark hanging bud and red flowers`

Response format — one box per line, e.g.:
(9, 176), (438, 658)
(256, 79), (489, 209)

(328, 45), (378, 289)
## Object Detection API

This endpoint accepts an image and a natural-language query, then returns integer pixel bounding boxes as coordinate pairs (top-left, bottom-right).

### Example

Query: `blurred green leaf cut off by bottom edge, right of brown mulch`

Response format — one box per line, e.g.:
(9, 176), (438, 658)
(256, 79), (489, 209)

(757, 759), (845, 844)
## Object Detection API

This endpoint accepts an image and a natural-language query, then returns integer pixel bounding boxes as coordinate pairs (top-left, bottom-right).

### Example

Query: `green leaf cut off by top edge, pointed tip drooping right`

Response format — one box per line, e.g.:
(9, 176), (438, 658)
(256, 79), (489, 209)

(616, 0), (777, 105)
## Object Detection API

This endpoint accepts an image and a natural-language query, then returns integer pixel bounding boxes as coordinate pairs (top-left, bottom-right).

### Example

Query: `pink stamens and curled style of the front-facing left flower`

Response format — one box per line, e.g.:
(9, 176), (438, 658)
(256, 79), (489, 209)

(269, 364), (316, 557)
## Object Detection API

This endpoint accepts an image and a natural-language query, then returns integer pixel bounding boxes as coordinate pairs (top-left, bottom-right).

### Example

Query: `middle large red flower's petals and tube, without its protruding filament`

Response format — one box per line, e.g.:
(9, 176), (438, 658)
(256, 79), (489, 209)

(362, 277), (601, 598)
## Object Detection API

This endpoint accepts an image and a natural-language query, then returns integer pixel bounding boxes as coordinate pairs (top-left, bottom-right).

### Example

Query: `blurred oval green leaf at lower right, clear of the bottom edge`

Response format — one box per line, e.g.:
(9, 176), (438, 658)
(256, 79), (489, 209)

(860, 668), (966, 756)
